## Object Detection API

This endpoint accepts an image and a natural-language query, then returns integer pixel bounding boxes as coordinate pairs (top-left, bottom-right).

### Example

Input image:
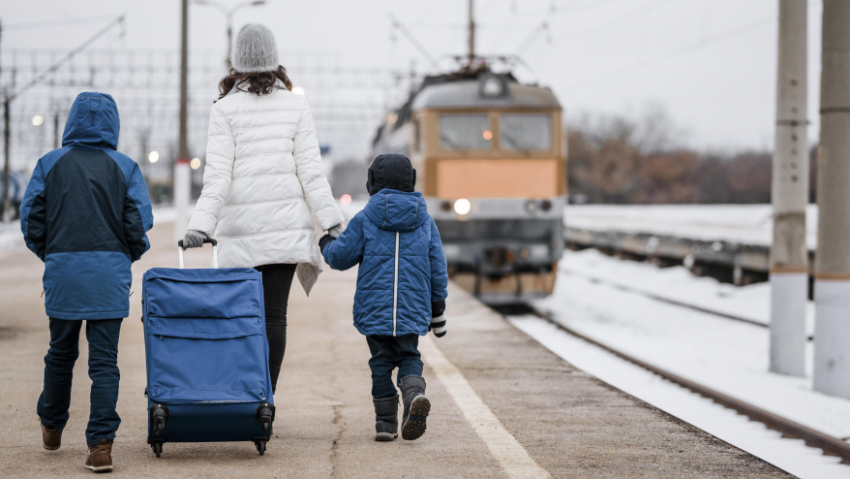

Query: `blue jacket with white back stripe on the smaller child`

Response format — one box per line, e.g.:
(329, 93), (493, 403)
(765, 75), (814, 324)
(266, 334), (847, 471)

(322, 189), (449, 336)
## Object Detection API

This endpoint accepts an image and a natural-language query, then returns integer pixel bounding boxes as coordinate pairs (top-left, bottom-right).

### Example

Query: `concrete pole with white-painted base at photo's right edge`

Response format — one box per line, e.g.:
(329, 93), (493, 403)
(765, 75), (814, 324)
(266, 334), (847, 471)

(814, 0), (850, 399)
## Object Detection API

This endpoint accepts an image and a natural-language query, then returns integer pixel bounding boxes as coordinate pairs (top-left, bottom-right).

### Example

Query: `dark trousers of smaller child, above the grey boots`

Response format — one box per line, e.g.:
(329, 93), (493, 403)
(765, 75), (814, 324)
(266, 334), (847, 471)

(366, 334), (422, 399)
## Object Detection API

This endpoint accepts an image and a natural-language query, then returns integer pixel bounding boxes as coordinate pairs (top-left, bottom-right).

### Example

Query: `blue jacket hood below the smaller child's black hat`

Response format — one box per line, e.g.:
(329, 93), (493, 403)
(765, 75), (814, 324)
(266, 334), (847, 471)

(364, 188), (430, 231)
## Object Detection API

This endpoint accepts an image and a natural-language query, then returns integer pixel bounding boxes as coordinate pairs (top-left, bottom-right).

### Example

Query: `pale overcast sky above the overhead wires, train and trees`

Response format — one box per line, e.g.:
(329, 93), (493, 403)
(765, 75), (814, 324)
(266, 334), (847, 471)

(0, 0), (821, 153)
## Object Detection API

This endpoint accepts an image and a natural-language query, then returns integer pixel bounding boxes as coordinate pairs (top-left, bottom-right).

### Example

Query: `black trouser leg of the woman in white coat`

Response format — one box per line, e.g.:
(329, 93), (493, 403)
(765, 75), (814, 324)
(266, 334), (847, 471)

(256, 264), (296, 394)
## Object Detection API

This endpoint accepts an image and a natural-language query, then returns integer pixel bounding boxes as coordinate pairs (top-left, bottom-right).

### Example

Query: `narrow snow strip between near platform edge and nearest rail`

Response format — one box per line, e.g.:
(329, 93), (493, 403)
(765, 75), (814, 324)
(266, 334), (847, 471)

(509, 316), (850, 479)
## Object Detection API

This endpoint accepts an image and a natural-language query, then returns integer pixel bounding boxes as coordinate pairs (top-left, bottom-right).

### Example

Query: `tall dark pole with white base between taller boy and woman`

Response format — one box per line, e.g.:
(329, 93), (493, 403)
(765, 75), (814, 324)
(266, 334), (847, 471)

(174, 0), (190, 240)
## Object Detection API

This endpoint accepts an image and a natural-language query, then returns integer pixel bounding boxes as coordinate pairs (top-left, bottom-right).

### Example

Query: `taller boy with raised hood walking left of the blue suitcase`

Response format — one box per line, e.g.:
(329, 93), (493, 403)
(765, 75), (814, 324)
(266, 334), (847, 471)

(21, 93), (153, 472)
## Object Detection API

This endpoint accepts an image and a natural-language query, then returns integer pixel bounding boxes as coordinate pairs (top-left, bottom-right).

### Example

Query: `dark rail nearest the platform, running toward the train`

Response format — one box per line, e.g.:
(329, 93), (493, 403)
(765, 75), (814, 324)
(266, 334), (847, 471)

(500, 306), (850, 464)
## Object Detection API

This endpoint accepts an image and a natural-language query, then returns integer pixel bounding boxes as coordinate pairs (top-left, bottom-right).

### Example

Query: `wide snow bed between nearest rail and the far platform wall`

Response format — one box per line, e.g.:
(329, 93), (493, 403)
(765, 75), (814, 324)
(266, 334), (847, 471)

(535, 251), (850, 438)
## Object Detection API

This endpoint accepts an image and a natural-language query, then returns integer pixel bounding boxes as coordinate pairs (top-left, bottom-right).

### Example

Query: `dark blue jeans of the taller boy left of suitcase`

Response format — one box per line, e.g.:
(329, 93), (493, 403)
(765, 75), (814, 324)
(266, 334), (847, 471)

(37, 318), (122, 446)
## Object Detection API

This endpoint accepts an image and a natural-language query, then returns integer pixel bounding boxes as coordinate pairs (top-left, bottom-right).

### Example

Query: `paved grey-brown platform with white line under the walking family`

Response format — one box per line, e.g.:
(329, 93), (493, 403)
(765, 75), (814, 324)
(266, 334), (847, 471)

(0, 223), (791, 479)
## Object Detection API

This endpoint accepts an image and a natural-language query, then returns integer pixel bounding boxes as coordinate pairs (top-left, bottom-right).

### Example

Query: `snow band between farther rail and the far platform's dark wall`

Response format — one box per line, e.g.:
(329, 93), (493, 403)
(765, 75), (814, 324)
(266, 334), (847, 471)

(559, 249), (815, 335)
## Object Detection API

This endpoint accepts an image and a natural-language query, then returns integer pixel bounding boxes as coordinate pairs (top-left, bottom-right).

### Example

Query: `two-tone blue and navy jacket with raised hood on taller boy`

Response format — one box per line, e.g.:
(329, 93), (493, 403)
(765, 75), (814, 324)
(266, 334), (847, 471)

(21, 93), (153, 319)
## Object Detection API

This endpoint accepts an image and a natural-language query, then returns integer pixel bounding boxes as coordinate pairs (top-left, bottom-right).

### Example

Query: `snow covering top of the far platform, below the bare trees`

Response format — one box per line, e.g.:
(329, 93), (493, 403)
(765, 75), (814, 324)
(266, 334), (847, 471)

(564, 205), (818, 248)
